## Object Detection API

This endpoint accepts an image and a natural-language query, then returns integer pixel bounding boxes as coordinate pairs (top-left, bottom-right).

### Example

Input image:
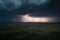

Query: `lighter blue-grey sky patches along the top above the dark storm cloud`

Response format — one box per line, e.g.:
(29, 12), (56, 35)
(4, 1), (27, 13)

(0, 0), (50, 10)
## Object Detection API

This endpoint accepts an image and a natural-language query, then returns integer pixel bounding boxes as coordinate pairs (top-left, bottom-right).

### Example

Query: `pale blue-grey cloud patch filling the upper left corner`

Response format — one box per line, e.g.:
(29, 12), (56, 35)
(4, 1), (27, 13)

(0, 0), (21, 11)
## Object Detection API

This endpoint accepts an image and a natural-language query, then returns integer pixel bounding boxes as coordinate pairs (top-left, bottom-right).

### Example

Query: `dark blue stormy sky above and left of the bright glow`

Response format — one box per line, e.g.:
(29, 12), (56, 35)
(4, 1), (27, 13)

(0, 0), (60, 23)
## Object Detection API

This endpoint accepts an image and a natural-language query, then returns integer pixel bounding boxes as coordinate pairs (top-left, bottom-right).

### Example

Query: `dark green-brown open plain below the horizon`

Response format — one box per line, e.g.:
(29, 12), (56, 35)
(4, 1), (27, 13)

(0, 23), (60, 40)
